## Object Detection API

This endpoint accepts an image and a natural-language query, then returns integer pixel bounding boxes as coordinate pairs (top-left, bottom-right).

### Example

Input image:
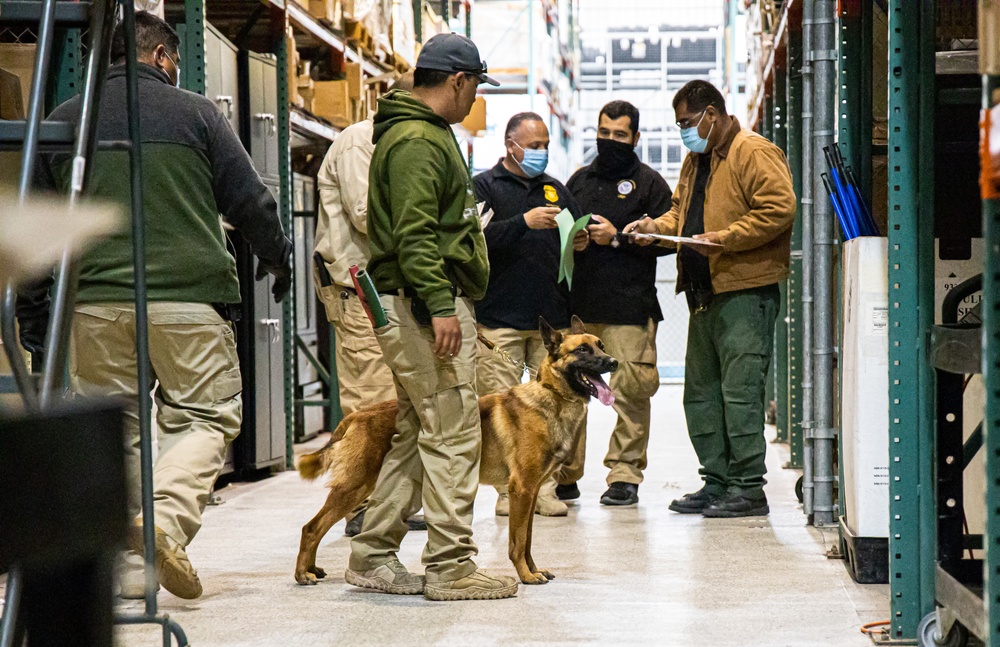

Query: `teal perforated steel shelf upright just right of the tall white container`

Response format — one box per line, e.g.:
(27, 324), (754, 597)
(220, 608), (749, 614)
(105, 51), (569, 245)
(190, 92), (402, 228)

(889, 0), (937, 639)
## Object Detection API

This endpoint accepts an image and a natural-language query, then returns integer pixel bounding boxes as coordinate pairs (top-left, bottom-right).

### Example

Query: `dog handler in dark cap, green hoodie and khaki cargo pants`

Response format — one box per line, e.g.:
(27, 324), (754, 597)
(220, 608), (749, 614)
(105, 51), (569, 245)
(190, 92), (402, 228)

(345, 34), (517, 600)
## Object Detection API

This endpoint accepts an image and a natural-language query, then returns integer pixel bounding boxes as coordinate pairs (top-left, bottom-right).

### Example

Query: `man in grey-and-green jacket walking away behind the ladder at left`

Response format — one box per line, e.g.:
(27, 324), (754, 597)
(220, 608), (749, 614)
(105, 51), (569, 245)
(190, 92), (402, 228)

(18, 12), (291, 599)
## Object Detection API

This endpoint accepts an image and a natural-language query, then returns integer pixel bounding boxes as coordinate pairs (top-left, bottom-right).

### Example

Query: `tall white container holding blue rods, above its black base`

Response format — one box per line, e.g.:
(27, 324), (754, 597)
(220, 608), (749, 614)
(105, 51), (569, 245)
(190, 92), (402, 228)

(841, 237), (889, 537)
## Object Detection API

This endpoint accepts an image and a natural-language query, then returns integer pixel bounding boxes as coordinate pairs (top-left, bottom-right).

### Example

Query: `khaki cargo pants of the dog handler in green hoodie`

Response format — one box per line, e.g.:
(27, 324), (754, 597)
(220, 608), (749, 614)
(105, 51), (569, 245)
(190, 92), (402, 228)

(350, 296), (482, 582)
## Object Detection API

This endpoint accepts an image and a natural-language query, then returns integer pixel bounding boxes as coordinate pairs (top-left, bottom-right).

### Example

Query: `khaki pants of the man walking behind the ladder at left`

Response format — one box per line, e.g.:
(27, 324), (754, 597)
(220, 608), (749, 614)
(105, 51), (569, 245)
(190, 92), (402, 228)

(70, 303), (243, 546)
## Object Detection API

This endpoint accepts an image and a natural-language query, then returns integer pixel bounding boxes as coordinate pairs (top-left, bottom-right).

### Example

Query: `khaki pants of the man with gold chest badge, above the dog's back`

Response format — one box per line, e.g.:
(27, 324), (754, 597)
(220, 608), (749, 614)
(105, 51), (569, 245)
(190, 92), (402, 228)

(476, 326), (546, 396)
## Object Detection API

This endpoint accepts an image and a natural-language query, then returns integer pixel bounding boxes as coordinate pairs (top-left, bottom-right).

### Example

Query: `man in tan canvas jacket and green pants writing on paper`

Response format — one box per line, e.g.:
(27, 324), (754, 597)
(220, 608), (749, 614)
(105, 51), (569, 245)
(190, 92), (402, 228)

(630, 81), (795, 517)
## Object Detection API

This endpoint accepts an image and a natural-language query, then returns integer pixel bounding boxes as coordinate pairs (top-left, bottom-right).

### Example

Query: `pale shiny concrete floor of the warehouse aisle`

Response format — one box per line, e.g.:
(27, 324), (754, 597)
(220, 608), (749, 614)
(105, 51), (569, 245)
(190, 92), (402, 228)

(105, 386), (888, 647)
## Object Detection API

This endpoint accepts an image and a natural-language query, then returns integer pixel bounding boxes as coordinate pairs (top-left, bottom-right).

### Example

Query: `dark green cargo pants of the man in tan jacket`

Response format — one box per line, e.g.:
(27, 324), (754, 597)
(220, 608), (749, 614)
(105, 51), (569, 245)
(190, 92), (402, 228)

(684, 285), (779, 493)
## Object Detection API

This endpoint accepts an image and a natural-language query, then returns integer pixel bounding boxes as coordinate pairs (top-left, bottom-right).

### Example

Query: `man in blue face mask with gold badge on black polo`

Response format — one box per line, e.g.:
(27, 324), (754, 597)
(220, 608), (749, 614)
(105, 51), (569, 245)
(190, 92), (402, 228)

(473, 112), (588, 516)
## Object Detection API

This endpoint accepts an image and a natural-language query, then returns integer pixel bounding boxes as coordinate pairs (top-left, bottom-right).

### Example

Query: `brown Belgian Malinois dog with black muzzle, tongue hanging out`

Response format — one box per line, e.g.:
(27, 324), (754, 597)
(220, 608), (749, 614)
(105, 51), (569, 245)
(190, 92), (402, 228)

(295, 316), (618, 584)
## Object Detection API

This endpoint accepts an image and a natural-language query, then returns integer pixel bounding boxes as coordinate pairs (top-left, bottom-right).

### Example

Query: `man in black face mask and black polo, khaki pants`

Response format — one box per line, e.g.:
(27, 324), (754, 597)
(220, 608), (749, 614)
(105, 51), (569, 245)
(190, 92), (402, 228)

(557, 101), (671, 505)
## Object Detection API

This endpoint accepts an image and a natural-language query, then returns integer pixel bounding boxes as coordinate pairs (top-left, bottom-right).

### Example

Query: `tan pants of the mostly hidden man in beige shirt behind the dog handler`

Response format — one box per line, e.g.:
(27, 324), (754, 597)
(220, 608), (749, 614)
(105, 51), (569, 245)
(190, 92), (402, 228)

(316, 281), (396, 416)
